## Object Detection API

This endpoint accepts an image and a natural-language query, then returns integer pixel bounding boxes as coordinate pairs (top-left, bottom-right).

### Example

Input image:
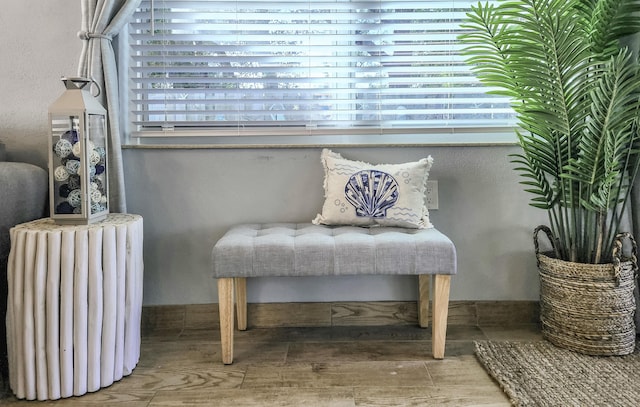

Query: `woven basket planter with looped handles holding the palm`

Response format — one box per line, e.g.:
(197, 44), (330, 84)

(534, 226), (637, 356)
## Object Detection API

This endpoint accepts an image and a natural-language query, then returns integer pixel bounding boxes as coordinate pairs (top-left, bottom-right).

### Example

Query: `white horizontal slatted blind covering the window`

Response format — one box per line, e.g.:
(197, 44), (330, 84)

(129, 0), (514, 135)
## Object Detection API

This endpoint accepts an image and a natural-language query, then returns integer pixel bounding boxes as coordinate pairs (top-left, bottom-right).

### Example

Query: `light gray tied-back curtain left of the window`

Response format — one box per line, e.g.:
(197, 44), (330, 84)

(78, 0), (140, 213)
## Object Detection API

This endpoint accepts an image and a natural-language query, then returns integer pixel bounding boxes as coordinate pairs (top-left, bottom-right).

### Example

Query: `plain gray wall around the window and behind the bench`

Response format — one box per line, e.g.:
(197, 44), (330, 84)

(0, 0), (546, 305)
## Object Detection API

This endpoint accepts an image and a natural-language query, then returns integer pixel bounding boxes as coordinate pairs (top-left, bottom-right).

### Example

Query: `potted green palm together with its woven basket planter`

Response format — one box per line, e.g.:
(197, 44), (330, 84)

(460, 0), (640, 355)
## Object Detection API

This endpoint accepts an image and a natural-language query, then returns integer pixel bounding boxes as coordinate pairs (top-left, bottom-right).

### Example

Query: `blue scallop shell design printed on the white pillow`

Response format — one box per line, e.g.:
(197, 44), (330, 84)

(344, 170), (398, 218)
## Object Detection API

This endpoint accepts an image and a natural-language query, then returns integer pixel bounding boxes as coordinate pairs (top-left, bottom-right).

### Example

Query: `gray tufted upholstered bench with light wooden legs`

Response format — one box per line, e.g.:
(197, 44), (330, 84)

(212, 223), (456, 364)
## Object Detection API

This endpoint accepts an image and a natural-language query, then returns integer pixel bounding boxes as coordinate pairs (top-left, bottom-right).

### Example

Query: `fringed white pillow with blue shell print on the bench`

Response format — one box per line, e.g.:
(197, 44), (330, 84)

(313, 149), (433, 229)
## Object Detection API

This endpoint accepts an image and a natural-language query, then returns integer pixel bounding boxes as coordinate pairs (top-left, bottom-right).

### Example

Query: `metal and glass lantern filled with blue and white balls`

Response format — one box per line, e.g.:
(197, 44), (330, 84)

(49, 78), (109, 225)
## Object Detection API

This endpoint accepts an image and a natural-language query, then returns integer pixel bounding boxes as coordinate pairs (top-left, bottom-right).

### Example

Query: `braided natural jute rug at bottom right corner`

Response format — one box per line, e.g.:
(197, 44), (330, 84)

(475, 341), (640, 407)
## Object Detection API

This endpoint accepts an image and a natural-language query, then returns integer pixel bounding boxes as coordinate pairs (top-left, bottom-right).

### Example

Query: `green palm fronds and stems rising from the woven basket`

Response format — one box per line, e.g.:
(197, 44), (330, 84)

(460, 0), (640, 263)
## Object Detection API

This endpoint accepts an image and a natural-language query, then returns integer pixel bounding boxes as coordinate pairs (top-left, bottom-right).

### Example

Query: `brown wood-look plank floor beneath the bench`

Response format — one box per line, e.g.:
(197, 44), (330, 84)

(0, 324), (541, 407)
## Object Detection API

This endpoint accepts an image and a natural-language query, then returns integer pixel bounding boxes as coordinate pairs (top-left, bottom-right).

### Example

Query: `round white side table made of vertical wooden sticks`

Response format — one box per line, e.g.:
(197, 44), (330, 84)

(6, 214), (144, 400)
